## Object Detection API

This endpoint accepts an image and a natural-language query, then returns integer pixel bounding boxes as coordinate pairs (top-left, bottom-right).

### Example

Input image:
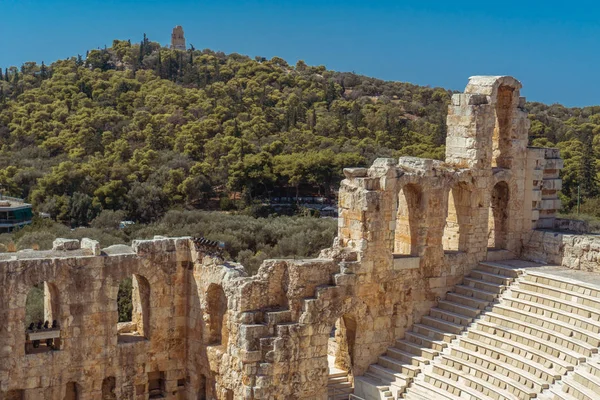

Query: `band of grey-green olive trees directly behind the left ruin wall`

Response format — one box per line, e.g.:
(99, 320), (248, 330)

(0, 210), (337, 273)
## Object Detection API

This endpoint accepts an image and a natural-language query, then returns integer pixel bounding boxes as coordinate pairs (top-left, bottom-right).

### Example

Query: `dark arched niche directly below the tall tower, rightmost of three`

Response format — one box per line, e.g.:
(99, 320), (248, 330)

(488, 182), (509, 250)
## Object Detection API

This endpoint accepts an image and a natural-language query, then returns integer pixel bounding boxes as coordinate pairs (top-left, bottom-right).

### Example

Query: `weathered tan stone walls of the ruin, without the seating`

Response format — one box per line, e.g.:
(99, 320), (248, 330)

(0, 77), (592, 400)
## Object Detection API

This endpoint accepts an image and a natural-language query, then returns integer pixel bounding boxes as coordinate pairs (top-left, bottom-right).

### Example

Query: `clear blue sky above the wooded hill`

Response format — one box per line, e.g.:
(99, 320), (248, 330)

(0, 0), (600, 106)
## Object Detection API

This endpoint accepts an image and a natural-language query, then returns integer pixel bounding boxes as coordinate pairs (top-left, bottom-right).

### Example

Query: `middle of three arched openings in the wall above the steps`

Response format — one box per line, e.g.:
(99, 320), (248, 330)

(442, 183), (473, 252)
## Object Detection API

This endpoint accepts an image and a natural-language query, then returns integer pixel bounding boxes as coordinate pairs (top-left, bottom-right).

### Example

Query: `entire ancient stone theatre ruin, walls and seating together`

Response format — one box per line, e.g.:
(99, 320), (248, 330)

(0, 76), (600, 400)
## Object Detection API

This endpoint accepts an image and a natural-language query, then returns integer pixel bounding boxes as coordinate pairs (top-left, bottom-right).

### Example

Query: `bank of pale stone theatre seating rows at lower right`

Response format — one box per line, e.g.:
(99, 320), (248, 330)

(403, 263), (600, 400)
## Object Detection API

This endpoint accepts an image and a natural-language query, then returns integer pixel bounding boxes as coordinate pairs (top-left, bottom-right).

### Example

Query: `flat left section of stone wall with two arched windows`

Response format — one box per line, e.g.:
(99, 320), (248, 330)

(0, 239), (189, 400)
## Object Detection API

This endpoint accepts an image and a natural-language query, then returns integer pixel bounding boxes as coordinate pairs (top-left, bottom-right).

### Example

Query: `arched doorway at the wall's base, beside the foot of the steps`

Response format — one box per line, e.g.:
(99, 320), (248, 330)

(327, 315), (356, 398)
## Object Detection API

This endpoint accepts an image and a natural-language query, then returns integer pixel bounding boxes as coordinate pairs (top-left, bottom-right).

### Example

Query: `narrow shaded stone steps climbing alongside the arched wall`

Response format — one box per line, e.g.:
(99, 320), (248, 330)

(355, 262), (518, 400)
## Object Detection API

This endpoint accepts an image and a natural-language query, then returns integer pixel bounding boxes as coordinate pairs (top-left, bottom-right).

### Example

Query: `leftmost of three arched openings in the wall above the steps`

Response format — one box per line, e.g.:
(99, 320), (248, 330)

(394, 184), (423, 256)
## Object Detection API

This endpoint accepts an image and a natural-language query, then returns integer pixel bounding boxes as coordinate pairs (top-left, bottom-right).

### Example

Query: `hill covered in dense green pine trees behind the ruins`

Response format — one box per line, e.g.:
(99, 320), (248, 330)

(0, 37), (600, 226)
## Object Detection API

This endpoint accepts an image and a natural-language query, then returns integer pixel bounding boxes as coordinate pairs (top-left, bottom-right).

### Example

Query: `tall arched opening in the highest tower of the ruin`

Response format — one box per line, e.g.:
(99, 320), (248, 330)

(492, 85), (515, 168)
